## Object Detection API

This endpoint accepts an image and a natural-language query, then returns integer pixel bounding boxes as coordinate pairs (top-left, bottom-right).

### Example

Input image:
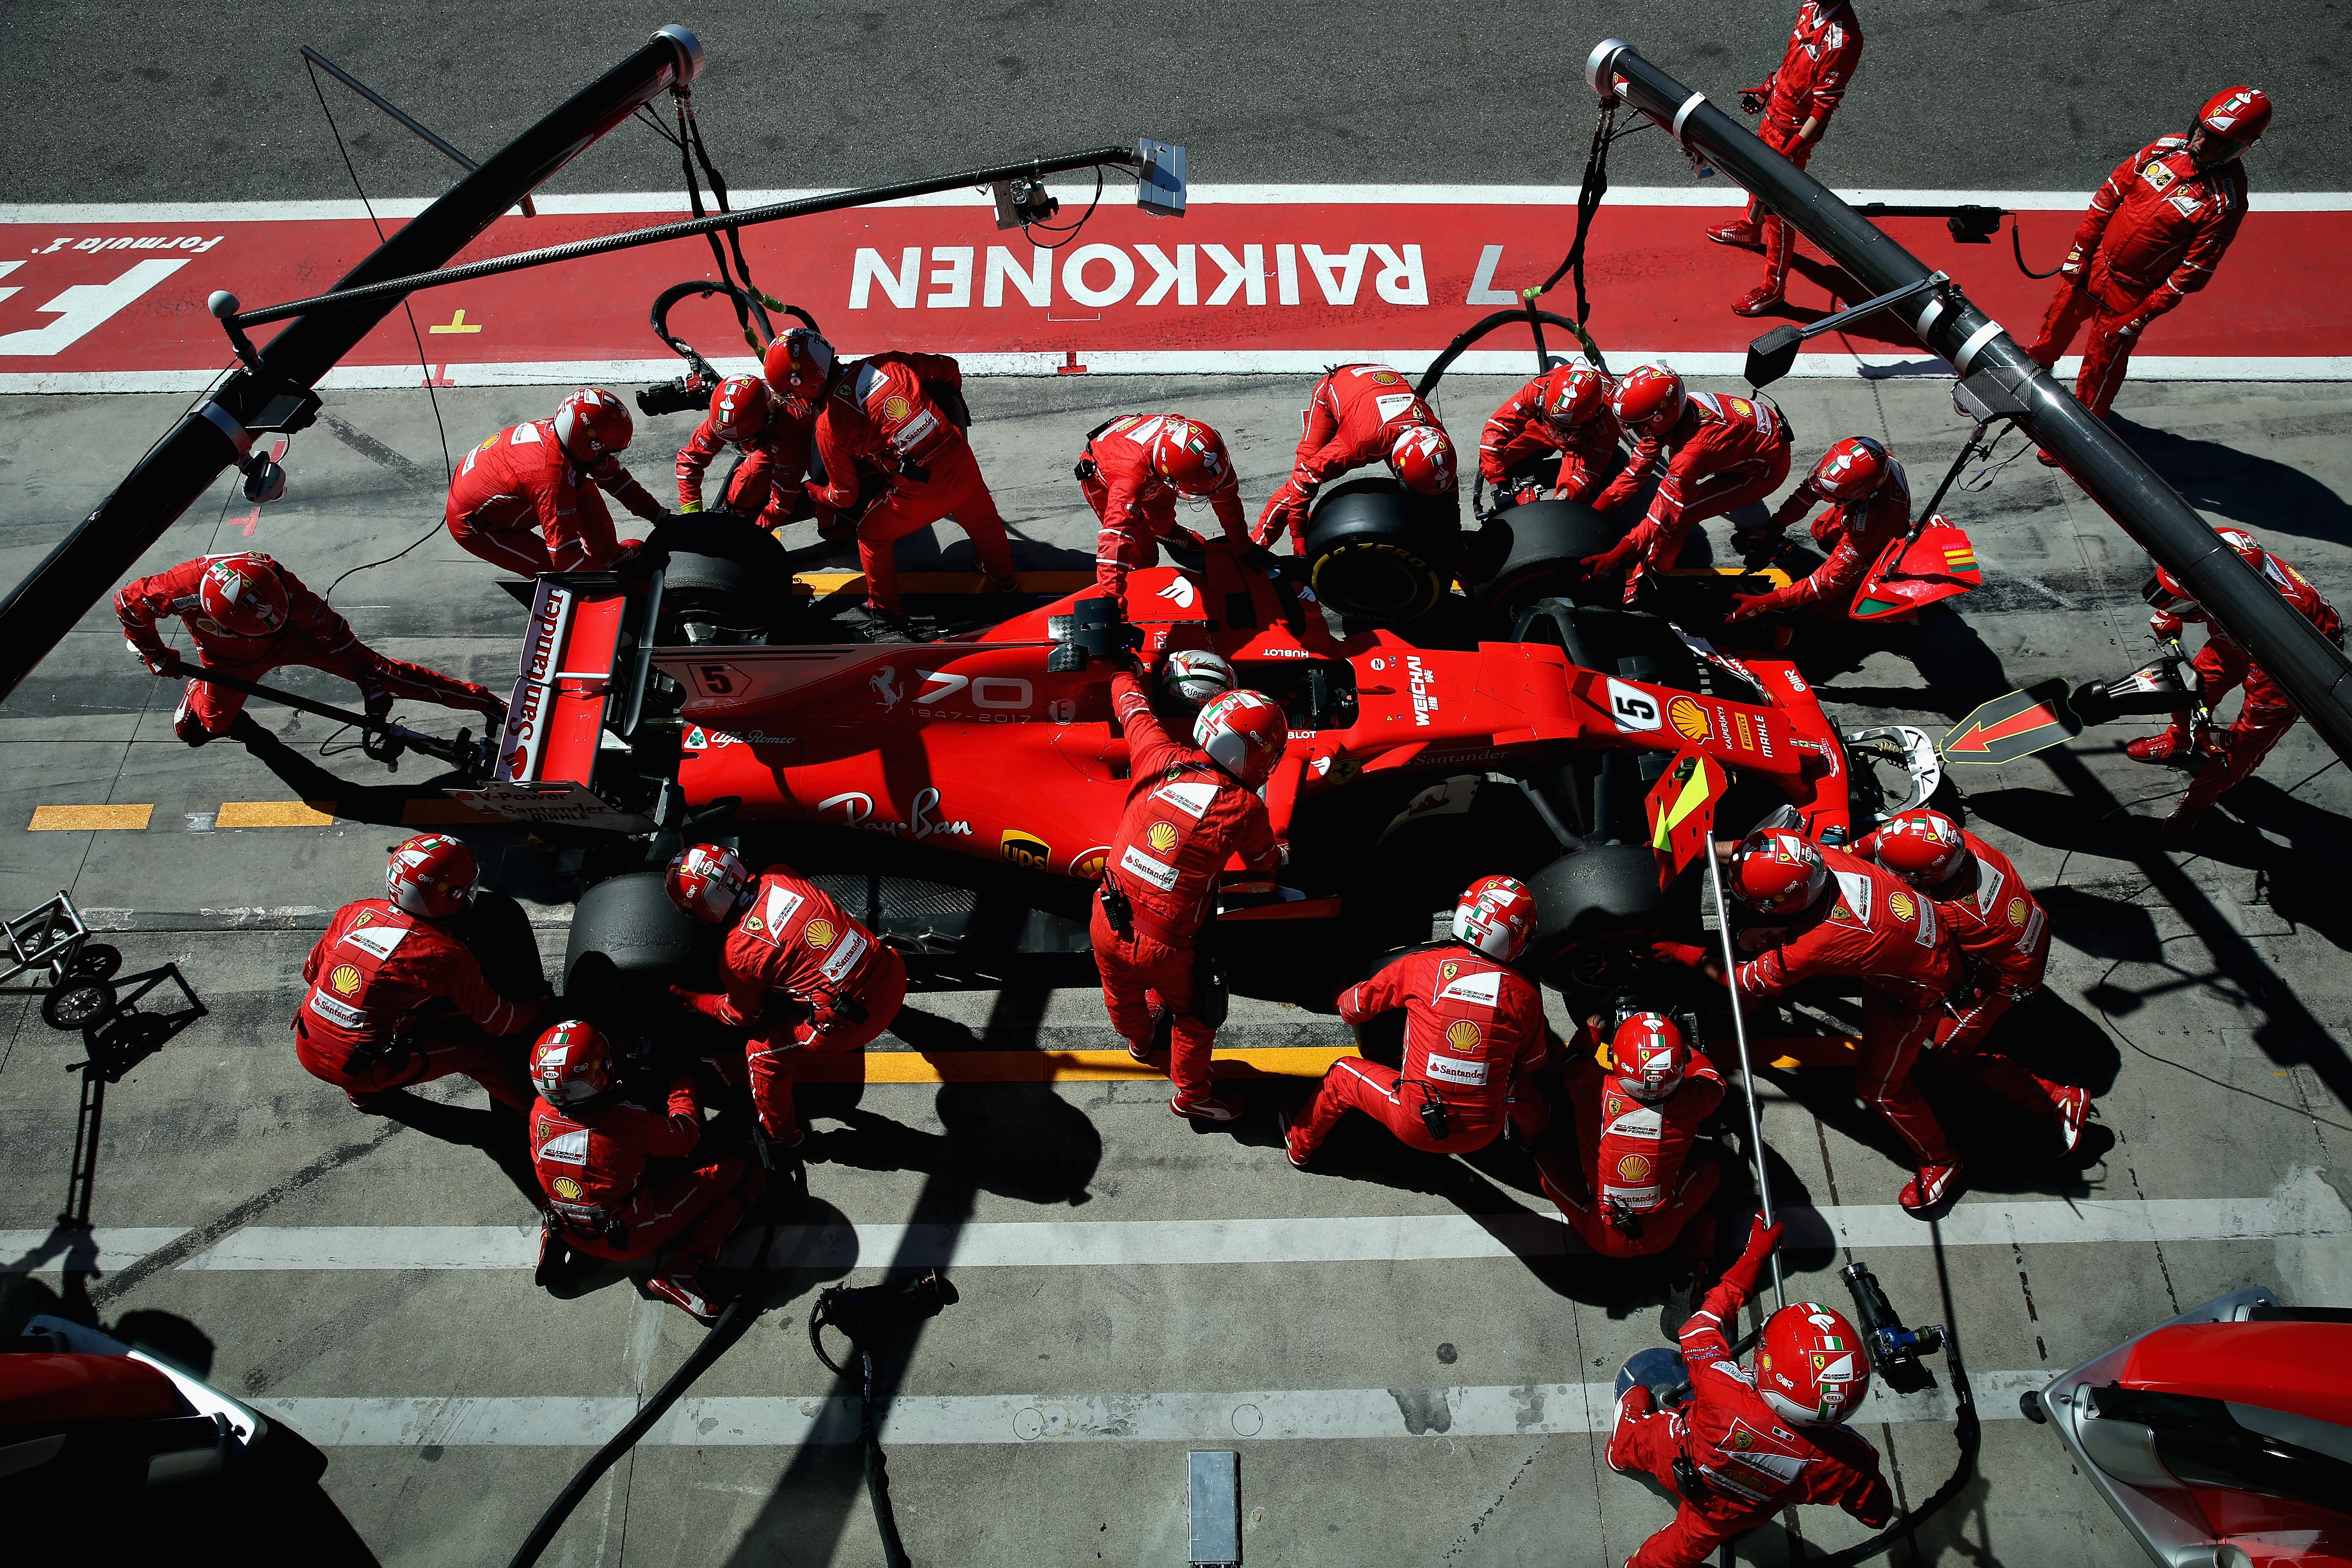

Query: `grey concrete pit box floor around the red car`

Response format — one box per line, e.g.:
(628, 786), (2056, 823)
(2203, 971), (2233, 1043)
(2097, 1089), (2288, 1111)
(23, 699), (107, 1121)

(0, 362), (2352, 1568)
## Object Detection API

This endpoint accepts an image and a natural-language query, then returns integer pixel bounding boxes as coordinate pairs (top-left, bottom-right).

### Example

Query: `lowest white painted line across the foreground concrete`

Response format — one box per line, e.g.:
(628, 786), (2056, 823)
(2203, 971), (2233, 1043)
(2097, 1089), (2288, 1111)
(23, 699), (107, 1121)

(249, 1368), (2060, 1448)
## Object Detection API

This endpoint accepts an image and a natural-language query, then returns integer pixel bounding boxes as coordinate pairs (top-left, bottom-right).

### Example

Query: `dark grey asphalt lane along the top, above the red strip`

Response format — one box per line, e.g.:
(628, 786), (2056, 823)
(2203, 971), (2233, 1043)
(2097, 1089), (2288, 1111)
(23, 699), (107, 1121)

(0, 0), (2352, 202)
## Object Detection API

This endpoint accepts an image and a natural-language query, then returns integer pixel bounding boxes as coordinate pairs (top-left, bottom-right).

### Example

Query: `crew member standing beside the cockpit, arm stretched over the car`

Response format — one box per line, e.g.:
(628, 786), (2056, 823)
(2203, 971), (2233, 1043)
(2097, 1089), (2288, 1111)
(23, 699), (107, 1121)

(1089, 670), (1291, 1121)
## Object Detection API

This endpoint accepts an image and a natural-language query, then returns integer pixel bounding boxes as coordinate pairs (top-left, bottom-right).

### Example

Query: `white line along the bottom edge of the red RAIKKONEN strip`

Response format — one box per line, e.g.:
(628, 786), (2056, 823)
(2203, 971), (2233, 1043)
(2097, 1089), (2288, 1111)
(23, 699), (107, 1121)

(18, 348), (2352, 397)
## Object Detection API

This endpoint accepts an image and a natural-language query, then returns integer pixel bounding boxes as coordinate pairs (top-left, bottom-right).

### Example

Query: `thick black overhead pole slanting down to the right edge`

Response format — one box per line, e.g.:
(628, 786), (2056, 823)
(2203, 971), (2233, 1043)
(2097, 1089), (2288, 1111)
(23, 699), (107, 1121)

(1585, 38), (2352, 757)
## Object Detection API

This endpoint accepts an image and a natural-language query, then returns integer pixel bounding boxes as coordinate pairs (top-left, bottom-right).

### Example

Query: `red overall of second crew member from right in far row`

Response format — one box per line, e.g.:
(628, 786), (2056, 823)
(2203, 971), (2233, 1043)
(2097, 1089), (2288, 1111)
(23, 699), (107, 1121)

(1590, 392), (1790, 599)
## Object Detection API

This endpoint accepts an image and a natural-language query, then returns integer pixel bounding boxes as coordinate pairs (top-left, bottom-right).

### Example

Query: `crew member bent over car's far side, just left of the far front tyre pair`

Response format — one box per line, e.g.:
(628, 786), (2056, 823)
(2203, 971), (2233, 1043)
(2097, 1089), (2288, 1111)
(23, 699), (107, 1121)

(1077, 414), (1249, 611)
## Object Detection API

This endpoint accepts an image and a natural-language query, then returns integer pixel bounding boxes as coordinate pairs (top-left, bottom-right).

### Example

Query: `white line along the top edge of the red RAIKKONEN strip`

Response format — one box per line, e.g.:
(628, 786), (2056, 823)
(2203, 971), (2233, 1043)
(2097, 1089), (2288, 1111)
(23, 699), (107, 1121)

(0, 188), (2352, 222)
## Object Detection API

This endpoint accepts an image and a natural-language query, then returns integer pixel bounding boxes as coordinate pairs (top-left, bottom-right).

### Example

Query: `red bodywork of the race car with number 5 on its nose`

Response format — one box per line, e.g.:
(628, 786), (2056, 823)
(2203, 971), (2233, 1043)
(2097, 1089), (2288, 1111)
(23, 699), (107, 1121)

(654, 543), (1846, 877)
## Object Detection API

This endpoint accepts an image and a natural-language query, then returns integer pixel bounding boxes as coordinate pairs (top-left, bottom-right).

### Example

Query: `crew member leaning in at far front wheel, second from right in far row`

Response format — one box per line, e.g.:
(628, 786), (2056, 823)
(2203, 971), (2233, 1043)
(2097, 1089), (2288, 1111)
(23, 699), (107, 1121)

(1585, 364), (1790, 604)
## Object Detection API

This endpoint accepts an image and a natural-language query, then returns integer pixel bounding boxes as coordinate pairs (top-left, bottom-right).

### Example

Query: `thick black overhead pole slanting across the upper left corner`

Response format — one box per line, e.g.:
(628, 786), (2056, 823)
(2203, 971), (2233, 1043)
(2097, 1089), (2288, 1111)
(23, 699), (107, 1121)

(0, 26), (703, 698)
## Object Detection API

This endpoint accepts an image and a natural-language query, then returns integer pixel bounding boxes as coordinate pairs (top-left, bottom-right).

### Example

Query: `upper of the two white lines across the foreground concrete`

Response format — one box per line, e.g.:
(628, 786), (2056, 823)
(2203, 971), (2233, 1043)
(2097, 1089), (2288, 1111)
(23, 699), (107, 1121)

(169, 1196), (2352, 1272)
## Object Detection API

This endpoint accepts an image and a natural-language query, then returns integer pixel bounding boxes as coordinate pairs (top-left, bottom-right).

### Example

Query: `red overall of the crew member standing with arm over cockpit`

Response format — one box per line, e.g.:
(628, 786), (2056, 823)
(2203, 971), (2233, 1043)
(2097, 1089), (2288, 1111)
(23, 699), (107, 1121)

(1089, 670), (1282, 1102)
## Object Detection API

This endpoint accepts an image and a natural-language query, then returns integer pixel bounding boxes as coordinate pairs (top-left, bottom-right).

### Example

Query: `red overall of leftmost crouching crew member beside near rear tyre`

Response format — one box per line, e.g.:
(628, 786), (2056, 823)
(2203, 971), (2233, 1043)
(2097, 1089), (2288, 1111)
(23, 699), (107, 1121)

(294, 898), (539, 1109)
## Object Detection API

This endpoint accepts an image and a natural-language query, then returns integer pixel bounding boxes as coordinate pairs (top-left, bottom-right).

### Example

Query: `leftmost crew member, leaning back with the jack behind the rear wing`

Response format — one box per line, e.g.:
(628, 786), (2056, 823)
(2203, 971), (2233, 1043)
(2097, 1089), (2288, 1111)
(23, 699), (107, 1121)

(115, 552), (506, 745)
